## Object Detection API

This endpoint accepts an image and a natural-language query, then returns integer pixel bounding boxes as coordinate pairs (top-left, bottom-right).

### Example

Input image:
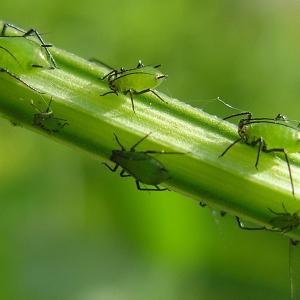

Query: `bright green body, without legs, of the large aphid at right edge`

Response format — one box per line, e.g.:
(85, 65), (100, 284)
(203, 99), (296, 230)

(245, 123), (300, 153)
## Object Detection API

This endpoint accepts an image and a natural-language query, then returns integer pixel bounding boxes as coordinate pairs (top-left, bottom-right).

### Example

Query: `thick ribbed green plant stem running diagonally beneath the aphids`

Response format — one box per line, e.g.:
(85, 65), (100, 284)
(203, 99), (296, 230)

(0, 21), (300, 240)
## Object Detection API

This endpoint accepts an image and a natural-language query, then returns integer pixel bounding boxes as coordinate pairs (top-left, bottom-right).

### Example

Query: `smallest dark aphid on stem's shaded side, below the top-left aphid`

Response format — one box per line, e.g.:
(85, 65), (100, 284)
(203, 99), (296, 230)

(31, 98), (69, 134)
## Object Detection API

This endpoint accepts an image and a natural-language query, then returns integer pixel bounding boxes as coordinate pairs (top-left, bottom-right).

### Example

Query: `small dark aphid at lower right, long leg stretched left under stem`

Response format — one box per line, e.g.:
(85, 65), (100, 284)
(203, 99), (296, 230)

(235, 203), (300, 245)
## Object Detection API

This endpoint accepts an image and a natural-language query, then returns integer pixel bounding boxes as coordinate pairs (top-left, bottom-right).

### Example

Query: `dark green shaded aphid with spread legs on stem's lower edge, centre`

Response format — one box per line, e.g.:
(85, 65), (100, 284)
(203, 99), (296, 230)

(103, 133), (184, 191)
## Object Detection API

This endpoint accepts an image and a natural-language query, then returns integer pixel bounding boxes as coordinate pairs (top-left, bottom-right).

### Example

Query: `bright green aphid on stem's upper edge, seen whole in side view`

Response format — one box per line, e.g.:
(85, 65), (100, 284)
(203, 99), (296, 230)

(101, 61), (167, 112)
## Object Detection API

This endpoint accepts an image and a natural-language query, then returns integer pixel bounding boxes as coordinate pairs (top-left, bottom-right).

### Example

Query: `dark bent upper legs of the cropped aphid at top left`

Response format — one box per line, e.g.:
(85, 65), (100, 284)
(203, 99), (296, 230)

(0, 23), (57, 69)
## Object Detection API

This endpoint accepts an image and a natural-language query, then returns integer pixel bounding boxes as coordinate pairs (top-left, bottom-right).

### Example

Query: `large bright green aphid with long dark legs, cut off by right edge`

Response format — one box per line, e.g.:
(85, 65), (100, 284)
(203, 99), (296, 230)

(220, 112), (300, 195)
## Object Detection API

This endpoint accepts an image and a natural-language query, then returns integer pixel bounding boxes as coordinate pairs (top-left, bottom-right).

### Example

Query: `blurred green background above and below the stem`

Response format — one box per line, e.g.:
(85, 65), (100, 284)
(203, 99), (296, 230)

(0, 0), (300, 300)
